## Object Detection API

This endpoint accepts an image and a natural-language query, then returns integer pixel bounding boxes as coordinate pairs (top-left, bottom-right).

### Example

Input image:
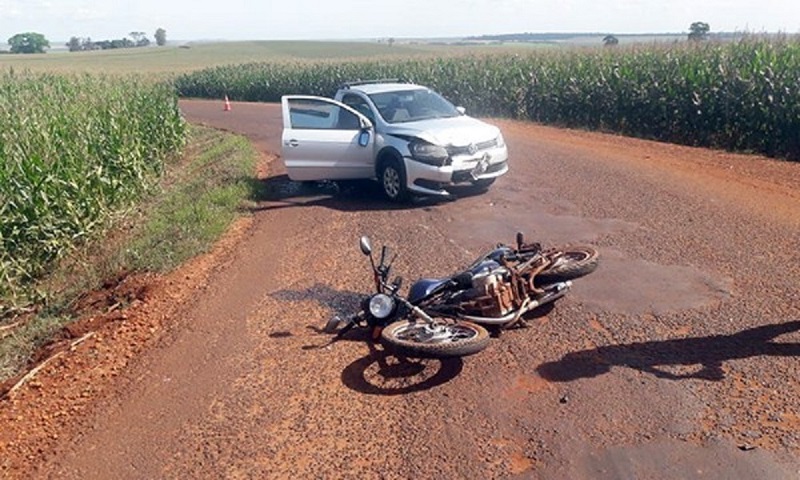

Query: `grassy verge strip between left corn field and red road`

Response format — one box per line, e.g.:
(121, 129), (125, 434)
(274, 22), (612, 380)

(0, 126), (259, 382)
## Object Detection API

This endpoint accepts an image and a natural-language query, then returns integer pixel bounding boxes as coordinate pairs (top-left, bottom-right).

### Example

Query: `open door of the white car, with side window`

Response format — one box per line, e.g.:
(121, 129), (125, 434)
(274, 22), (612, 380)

(281, 95), (375, 181)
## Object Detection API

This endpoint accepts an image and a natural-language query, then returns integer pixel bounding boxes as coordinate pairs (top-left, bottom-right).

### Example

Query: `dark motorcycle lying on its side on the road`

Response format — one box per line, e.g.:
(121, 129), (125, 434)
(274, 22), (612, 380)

(324, 233), (599, 358)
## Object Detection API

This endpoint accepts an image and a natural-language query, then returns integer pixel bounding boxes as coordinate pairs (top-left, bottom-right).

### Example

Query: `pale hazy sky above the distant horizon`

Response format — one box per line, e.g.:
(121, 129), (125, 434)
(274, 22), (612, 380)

(0, 0), (800, 42)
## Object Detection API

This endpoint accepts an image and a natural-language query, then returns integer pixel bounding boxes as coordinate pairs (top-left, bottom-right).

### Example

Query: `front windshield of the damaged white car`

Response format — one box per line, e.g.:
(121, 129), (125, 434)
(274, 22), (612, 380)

(370, 89), (460, 123)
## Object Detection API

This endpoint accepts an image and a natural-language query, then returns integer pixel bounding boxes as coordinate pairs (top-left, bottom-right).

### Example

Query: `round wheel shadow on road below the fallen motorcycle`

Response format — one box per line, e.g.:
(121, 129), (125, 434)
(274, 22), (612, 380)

(342, 342), (464, 396)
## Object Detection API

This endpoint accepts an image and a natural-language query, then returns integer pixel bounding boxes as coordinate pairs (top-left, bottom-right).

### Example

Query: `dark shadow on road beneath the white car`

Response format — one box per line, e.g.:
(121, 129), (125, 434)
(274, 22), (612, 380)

(251, 175), (486, 212)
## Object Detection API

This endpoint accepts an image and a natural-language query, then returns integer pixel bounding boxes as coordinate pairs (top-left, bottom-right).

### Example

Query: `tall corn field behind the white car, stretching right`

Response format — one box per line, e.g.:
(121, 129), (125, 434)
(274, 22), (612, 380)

(177, 37), (800, 160)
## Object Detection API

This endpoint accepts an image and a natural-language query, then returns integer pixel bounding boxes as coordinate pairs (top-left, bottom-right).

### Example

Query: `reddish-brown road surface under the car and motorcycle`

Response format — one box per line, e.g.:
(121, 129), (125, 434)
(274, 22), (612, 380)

(0, 101), (800, 479)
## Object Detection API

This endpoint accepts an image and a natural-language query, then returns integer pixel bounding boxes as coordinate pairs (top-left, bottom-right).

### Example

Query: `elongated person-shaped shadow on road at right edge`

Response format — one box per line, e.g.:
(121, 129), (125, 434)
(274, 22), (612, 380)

(536, 321), (800, 382)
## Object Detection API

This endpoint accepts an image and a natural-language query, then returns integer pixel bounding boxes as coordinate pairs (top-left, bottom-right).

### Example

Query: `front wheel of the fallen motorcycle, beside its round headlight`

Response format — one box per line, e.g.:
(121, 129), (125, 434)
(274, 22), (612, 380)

(381, 320), (489, 358)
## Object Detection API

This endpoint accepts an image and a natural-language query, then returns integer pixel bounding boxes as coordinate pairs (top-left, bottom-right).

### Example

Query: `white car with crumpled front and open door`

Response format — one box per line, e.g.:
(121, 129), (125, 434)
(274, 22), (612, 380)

(281, 81), (508, 201)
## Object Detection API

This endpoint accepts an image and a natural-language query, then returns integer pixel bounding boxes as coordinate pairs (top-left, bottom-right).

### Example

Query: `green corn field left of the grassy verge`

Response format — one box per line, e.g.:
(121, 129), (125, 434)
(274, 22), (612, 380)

(0, 72), (185, 304)
